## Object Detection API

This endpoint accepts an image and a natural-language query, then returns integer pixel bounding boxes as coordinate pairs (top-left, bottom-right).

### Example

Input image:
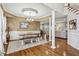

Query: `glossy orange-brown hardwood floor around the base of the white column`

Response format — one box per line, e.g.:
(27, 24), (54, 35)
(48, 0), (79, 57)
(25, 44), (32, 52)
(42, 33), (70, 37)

(6, 38), (79, 56)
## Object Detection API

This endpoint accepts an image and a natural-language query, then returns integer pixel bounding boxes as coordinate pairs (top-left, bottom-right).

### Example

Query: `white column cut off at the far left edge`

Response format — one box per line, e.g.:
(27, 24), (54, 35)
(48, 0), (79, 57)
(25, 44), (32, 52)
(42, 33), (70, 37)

(0, 6), (4, 55)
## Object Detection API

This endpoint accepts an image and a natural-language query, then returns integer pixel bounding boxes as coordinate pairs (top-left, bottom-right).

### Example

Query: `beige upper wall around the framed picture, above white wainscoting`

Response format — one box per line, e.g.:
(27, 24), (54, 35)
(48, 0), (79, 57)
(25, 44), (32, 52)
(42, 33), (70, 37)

(7, 17), (40, 31)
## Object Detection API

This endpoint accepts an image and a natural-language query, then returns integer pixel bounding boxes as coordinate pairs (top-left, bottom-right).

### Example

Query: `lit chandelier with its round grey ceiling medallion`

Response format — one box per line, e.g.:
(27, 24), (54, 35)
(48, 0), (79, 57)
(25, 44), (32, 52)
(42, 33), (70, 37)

(22, 8), (38, 21)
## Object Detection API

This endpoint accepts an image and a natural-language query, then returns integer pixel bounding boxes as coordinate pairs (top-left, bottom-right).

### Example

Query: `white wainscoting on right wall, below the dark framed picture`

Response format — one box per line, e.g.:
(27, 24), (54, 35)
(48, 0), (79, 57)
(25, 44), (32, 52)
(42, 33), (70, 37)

(68, 31), (79, 50)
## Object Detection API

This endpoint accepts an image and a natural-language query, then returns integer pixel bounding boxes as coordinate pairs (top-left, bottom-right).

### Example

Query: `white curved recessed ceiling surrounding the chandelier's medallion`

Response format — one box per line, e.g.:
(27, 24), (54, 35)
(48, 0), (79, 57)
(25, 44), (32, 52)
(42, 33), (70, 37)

(3, 3), (51, 18)
